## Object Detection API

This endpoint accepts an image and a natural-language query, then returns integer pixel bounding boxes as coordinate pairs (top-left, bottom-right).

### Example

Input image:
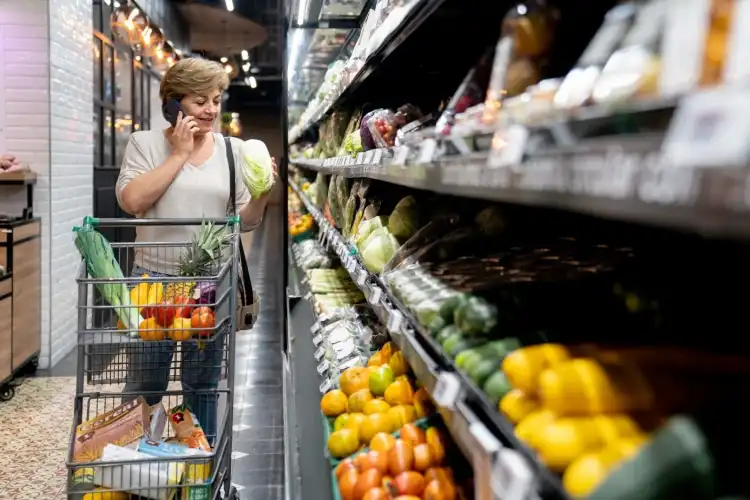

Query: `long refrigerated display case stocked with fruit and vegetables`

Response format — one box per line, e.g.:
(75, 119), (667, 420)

(287, 0), (750, 500)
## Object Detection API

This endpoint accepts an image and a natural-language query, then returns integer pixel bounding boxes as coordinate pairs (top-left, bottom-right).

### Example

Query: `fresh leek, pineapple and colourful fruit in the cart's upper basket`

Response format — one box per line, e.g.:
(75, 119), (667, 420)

(75, 222), (232, 341)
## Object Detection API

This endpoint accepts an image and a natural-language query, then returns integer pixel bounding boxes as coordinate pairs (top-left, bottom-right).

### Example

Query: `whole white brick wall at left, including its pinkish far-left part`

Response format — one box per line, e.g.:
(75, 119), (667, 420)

(0, 0), (93, 368)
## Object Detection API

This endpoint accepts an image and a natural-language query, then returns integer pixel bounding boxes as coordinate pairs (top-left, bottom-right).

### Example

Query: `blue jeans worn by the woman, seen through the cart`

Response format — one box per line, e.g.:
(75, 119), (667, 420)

(123, 267), (227, 446)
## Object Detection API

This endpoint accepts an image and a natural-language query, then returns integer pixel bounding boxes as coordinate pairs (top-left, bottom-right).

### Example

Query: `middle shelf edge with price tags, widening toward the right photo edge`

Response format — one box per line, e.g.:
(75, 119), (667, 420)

(291, 137), (750, 240)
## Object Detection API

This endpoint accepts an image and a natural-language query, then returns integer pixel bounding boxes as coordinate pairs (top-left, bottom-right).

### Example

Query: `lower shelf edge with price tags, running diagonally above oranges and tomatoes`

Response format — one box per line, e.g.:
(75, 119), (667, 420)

(289, 180), (568, 500)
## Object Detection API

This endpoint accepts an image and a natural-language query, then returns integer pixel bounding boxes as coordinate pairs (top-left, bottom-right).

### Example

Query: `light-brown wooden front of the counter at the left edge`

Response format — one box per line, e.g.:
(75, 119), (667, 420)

(0, 219), (42, 381)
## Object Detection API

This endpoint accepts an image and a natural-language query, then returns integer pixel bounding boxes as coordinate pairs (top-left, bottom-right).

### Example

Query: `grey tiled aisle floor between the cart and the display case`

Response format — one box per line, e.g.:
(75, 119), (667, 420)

(232, 207), (284, 500)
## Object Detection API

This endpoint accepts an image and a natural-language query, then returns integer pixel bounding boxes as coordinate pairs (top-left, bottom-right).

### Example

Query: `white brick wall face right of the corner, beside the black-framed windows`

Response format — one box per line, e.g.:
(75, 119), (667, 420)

(49, 0), (94, 366)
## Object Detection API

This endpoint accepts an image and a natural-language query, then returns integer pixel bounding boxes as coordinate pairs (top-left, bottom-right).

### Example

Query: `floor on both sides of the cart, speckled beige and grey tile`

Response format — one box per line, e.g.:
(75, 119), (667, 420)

(0, 208), (284, 500)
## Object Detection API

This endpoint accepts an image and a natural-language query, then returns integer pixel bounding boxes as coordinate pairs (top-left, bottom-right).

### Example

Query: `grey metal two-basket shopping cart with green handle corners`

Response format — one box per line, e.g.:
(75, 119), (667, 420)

(67, 217), (240, 500)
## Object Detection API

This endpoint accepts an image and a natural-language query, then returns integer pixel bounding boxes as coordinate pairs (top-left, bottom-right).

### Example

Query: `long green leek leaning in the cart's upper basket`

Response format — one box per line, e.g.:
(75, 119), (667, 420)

(75, 224), (140, 331)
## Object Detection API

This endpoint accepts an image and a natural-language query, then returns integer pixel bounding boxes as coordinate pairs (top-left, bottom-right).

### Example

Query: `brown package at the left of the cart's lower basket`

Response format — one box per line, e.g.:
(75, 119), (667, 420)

(73, 396), (149, 462)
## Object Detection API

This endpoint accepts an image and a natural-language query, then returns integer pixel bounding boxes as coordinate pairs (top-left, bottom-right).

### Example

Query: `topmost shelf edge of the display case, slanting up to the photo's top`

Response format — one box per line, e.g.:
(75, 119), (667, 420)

(289, 0), (445, 144)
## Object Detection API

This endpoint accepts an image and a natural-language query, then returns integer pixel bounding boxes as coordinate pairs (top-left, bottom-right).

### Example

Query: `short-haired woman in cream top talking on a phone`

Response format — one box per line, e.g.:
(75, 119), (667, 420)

(116, 59), (276, 441)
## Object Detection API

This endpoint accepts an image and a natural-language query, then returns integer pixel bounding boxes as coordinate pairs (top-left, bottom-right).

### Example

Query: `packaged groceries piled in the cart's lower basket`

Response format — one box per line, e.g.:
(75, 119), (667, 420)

(72, 397), (212, 500)
